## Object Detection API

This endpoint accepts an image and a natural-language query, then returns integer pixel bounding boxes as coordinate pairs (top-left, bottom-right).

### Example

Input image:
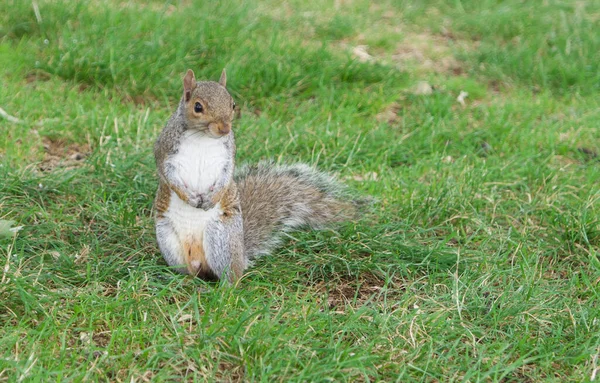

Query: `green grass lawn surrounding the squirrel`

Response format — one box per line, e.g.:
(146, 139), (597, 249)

(0, 0), (600, 382)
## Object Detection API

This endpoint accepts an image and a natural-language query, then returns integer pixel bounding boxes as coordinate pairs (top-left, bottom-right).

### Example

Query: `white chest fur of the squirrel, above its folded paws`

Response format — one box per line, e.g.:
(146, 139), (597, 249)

(168, 131), (229, 193)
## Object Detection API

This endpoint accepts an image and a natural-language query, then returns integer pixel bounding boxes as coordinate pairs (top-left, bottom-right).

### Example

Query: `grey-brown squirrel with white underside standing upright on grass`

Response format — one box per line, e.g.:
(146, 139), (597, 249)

(154, 69), (356, 282)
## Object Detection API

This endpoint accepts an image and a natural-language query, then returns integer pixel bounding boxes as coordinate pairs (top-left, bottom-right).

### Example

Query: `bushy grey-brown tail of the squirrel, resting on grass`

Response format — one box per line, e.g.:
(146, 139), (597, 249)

(235, 162), (356, 260)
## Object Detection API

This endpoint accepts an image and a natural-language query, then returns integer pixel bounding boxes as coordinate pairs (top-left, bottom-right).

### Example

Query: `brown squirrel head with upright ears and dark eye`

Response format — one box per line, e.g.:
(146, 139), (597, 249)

(183, 69), (235, 138)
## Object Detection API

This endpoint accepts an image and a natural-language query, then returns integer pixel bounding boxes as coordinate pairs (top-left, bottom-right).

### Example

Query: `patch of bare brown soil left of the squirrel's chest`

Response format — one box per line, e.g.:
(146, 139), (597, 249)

(38, 137), (90, 172)
